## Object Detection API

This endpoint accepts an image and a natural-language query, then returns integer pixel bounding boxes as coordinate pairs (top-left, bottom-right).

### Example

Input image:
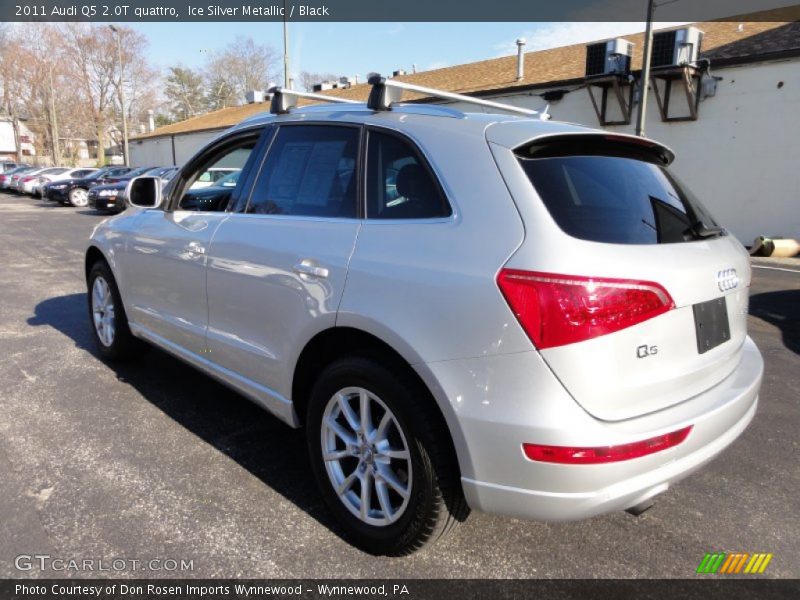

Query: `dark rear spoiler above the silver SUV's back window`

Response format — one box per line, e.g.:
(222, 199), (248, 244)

(514, 131), (675, 166)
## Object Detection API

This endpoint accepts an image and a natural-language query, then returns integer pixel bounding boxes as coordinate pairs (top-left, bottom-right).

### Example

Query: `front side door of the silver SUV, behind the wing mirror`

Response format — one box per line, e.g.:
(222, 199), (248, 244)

(118, 128), (263, 356)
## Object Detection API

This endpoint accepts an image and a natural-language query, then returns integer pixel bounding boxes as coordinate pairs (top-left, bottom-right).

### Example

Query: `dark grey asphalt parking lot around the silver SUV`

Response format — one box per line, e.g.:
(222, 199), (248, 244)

(0, 194), (800, 578)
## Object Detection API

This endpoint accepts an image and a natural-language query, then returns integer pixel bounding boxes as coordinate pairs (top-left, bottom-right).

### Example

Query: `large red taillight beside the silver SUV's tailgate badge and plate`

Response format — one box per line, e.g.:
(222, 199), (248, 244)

(497, 269), (675, 350)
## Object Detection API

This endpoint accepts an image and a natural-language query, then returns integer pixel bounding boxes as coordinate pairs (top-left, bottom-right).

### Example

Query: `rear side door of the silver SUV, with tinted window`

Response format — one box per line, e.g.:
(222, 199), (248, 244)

(207, 123), (361, 400)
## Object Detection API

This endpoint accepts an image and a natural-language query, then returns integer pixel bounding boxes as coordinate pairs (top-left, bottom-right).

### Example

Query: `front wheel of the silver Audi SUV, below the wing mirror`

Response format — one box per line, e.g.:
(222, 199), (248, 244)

(87, 260), (147, 361)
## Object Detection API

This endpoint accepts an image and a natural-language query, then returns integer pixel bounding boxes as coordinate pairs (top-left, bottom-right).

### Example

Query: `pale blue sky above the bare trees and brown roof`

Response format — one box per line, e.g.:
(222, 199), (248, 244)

(127, 22), (644, 83)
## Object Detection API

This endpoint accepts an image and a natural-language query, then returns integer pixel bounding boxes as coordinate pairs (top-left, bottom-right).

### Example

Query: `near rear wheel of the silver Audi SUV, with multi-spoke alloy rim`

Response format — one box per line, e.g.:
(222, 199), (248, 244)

(306, 356), (469, 556)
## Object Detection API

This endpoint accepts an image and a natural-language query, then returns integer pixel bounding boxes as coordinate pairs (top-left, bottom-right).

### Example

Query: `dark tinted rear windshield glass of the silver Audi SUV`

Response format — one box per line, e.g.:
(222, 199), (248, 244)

(519, 155), (724, 244)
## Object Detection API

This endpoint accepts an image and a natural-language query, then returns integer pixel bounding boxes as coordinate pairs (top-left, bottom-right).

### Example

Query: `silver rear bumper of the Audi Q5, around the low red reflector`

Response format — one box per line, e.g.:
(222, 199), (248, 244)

(422, 338), (763, 521)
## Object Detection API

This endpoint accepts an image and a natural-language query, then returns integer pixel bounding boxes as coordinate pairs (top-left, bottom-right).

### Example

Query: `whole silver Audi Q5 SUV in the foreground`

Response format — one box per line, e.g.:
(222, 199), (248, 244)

(86, 82), (763, 555)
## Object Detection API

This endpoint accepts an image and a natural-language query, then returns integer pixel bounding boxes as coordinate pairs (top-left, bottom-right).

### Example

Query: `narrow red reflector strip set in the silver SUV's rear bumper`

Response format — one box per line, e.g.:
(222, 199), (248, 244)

(522, 426), (692, 465)
